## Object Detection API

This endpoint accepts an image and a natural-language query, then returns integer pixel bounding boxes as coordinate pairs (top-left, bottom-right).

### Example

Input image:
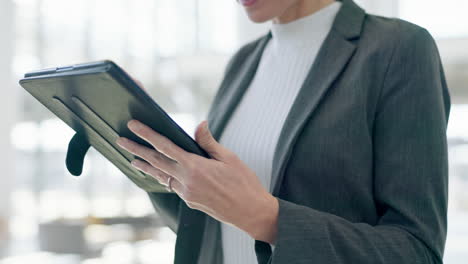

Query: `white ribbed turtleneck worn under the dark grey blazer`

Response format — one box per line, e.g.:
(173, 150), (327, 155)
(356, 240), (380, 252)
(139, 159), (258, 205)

(220, 2), (341, 264)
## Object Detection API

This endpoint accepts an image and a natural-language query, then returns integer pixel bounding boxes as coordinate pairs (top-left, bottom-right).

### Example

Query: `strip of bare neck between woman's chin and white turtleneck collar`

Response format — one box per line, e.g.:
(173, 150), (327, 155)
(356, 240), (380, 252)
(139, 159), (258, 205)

(273, 0), (336, 24)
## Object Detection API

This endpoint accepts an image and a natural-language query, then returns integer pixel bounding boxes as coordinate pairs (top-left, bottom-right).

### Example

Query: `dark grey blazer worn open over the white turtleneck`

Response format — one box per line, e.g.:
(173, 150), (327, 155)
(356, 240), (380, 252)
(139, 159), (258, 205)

(150, 0), (450, 264)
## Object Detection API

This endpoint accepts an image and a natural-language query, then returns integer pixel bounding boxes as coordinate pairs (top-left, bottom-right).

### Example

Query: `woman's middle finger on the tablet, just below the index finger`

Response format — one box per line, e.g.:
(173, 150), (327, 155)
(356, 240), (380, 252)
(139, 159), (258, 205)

(116, 137), (180, 177)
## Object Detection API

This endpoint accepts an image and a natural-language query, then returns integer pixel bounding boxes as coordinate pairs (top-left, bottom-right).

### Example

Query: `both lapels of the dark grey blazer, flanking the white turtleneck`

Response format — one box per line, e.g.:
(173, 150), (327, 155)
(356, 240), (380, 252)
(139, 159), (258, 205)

(209, 0), (365, 195)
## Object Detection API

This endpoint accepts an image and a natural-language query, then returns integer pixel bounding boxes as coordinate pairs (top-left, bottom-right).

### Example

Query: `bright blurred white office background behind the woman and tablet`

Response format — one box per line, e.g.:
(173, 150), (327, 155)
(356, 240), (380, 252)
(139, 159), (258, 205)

(0, 0), (468, 264)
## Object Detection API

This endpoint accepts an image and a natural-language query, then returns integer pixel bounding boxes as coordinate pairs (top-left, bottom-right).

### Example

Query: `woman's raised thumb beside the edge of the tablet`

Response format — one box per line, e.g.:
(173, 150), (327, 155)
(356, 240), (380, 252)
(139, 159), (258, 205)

(195, 120), (229, 160)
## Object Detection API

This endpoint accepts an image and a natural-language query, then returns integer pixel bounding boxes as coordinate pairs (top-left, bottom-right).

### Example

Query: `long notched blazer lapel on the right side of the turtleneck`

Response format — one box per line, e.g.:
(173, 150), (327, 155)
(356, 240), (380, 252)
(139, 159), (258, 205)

(270, 0), (365, 196)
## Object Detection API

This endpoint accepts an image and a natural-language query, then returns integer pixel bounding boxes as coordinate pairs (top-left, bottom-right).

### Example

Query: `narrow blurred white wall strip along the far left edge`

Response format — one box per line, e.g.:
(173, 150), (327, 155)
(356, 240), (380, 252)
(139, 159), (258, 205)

(0, 0), (17, 221)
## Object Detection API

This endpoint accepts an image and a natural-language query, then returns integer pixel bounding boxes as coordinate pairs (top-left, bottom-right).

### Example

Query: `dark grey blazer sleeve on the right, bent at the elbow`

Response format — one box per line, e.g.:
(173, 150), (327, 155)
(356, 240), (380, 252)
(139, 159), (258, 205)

(256, 27), (450, 264)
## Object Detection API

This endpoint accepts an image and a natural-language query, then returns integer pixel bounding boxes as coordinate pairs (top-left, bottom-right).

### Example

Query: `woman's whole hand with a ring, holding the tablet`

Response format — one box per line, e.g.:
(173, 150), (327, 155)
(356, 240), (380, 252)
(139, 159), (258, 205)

(117, 120), (278, 244)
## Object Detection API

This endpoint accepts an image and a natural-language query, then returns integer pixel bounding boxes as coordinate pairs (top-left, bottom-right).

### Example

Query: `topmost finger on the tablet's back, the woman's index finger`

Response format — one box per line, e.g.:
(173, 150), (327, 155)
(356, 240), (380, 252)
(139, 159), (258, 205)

(128, 119), (187, 163)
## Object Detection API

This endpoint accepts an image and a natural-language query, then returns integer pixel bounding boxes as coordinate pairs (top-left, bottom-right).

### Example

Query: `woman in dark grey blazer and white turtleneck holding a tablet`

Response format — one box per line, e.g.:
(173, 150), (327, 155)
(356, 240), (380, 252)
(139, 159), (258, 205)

(118, 0), (450, 264)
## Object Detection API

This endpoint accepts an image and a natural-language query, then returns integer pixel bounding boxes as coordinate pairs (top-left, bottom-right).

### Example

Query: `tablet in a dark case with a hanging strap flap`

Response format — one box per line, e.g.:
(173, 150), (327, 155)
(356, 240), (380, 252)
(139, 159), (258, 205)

(20, 61), (209, 192)
